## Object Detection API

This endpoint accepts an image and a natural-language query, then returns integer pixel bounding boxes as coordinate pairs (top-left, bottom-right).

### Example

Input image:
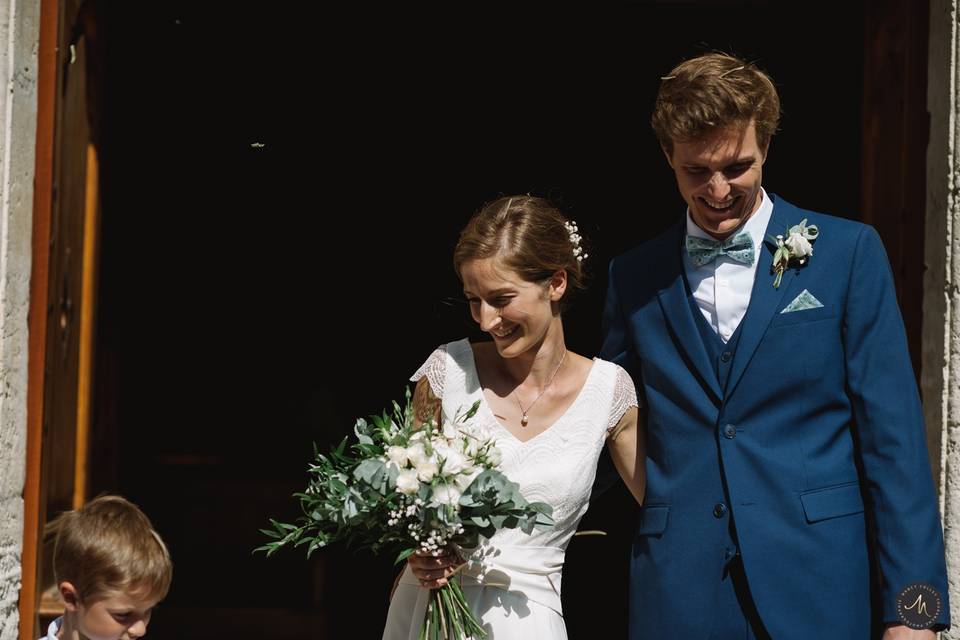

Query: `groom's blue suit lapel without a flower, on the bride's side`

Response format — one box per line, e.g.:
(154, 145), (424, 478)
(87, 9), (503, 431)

(657, 225), (723, 404)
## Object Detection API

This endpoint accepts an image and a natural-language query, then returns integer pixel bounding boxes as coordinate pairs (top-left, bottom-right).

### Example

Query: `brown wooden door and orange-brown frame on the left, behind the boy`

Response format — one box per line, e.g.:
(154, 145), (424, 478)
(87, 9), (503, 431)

(19, 0), (102, 639)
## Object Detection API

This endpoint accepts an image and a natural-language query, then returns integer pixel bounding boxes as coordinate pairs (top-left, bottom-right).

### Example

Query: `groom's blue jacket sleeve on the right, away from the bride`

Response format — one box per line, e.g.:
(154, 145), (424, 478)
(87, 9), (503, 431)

(843, 227), (950, 625)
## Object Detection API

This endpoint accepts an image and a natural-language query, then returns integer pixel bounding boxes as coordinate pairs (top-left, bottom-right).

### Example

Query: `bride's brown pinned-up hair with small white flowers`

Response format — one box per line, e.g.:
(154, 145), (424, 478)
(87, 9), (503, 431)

(453, 195), (586, 306)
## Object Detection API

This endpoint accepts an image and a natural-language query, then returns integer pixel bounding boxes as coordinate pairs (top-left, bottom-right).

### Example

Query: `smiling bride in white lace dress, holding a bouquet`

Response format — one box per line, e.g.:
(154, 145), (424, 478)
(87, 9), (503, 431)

(383, 196), (645, 640)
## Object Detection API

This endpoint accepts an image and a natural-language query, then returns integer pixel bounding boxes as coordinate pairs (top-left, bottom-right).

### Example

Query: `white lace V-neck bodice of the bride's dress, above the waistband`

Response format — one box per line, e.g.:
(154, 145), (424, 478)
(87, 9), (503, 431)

(411, 340), (637, 549)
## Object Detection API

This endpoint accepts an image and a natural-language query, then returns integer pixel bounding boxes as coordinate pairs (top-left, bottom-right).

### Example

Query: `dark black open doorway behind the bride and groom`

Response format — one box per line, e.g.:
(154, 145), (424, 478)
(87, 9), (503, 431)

(92, 0), (864, 640)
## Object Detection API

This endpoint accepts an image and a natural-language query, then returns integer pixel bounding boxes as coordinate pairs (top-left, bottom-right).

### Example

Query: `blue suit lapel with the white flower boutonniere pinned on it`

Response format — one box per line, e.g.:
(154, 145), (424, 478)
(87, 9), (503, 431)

(724, 198), (800, 397)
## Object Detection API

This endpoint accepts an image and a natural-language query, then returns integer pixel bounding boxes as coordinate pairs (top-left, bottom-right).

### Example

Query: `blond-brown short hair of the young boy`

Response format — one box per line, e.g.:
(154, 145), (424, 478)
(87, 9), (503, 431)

(47, 495), (173, 602)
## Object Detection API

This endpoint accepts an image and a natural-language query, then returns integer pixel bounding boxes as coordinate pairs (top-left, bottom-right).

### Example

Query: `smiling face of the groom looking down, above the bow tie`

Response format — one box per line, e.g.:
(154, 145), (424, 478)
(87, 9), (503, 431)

(664, 122), (769, 240)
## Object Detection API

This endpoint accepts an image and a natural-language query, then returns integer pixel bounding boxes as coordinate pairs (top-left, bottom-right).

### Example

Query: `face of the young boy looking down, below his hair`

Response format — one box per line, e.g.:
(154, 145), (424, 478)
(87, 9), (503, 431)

(64, 593), (158, 640)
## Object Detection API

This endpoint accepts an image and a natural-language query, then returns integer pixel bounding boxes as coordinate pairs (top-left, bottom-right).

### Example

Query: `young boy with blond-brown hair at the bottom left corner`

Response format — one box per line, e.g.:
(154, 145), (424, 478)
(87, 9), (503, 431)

(41, 495), (173, 640)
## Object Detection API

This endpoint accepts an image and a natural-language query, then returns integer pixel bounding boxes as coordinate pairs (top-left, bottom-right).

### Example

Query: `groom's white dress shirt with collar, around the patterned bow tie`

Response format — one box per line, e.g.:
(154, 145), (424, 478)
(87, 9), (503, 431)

(680, 188), (773, 342)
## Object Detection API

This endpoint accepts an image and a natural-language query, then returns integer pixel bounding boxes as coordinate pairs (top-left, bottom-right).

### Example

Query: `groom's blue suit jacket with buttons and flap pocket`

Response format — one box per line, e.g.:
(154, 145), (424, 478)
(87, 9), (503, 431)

(602, 196), (949, 640)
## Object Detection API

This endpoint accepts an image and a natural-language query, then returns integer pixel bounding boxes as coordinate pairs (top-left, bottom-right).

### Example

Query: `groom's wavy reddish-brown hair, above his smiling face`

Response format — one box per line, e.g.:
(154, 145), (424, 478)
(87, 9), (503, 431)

(650, 53), (780, 154)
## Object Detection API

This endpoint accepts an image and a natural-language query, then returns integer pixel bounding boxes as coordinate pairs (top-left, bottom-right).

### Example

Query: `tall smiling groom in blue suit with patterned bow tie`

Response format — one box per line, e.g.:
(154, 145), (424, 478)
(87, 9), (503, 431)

(602, 54), (949, 640)
